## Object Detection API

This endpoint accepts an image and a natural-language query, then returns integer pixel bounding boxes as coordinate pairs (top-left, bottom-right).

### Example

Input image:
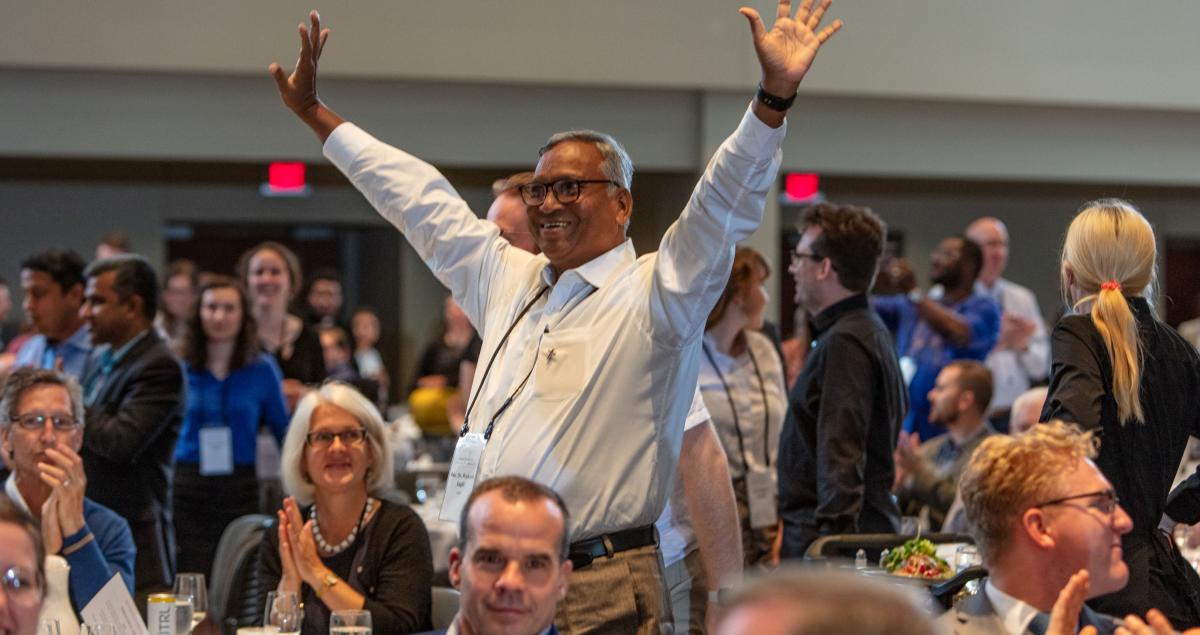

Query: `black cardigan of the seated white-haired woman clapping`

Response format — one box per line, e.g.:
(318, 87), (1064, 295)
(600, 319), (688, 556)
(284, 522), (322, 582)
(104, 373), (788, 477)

(258, 501), (433, 635)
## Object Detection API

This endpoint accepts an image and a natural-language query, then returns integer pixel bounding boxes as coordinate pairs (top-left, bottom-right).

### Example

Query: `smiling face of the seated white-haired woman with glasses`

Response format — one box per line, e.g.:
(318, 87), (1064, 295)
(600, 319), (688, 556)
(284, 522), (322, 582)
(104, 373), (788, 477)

(305, 403), (372, 496)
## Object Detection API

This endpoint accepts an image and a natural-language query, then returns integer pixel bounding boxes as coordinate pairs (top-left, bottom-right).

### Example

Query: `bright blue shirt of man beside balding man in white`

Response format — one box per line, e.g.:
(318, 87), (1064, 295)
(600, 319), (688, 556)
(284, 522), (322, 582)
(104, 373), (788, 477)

(871, 293), (1000, 441)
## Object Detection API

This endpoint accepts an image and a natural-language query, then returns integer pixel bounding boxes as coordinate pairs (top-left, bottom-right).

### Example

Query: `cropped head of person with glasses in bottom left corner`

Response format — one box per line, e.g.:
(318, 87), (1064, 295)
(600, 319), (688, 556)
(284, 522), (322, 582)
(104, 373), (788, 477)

(0, 496), (46, 635)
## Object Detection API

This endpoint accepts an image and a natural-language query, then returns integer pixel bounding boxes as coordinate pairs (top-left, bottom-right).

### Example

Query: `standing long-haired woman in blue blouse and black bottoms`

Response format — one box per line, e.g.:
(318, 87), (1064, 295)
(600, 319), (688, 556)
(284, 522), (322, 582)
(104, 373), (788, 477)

(174, 276), (288, 574)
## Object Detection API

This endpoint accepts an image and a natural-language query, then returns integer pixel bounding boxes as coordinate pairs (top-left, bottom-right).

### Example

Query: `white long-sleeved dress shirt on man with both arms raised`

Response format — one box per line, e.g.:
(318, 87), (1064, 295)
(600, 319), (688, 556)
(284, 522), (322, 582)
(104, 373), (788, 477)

(324, 109), (786, 540)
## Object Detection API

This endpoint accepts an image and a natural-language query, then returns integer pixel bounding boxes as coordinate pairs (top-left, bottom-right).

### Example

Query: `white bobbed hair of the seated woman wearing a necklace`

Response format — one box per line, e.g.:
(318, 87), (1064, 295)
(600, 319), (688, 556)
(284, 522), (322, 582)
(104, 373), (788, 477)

(280, 382), (396, 505)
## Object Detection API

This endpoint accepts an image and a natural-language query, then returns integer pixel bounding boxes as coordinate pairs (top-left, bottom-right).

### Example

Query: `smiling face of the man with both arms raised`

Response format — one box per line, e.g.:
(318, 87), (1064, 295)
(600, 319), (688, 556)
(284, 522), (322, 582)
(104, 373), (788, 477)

(526, 140), (634, 274)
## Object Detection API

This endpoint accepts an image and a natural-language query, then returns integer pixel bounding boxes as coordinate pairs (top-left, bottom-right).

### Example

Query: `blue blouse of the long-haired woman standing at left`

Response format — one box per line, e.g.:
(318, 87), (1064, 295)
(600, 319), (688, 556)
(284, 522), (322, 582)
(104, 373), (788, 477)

(175, 353), (288, 466)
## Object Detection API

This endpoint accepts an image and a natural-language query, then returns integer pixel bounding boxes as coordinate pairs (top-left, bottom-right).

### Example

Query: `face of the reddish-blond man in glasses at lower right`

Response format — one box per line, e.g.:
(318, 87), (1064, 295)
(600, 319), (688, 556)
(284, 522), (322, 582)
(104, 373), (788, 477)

(1043, 459), (1133, 598)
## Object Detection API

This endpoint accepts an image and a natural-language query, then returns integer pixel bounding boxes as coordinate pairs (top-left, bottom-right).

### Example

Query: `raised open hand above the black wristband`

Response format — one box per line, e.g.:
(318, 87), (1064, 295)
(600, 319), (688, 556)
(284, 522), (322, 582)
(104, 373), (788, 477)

(739, 0), (842, 98)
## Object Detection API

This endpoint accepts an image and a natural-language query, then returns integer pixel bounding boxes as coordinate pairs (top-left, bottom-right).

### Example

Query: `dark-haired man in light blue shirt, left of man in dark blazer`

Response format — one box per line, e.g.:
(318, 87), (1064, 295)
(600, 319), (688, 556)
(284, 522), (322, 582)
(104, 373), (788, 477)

(16, 251), (91, 379)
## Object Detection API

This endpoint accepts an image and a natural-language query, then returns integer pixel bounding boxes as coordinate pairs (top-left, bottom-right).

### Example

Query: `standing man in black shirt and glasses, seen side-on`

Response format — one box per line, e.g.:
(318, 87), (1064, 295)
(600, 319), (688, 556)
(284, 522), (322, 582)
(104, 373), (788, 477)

(779, 203), (908, 558)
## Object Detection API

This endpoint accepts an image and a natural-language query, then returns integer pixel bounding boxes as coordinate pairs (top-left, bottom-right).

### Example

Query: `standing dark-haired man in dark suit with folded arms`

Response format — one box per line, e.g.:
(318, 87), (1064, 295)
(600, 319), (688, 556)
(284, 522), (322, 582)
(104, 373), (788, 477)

(79, 254), (186, 593)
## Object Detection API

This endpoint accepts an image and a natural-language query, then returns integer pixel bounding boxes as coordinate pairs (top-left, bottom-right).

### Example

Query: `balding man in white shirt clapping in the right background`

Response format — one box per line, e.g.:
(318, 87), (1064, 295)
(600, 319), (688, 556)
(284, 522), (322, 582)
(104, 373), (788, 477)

(966, 216), (1050, 432)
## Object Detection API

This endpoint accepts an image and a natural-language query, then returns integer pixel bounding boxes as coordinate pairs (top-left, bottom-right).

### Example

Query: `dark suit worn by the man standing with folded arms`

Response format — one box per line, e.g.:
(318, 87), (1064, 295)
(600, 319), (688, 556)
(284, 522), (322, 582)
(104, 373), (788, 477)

(79, 328), (187, 589)
